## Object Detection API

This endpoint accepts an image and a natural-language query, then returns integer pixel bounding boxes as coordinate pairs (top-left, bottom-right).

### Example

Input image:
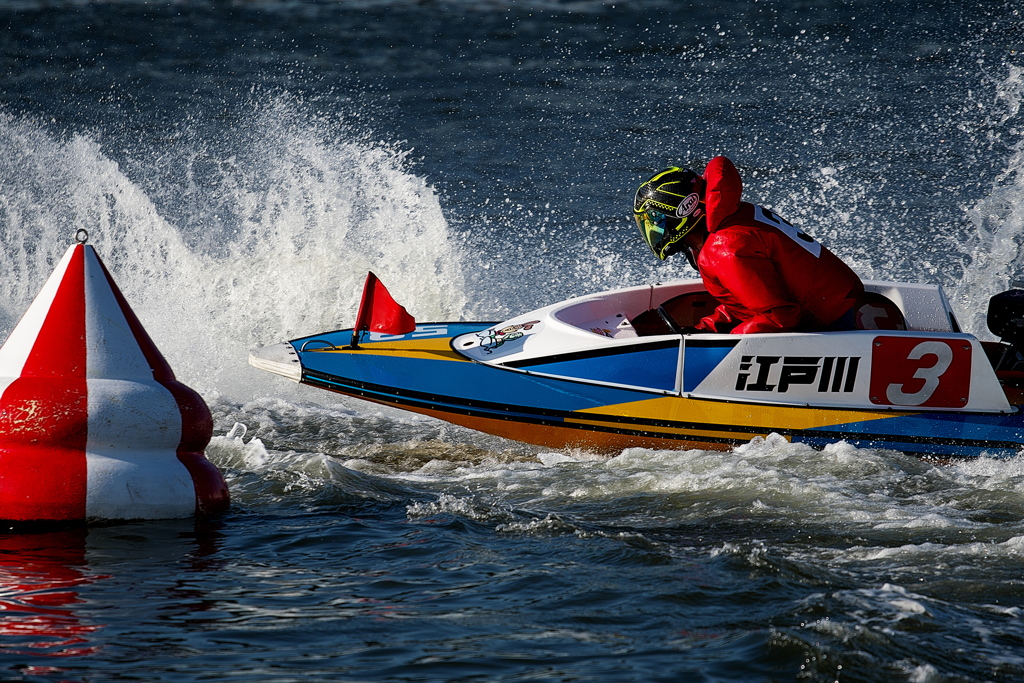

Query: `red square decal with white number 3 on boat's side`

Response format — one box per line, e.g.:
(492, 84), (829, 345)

(870, 337), (971, 408)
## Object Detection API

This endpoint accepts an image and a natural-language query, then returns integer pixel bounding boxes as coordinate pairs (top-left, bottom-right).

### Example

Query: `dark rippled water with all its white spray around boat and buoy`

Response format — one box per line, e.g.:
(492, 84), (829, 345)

(0, 0), (1024, 682)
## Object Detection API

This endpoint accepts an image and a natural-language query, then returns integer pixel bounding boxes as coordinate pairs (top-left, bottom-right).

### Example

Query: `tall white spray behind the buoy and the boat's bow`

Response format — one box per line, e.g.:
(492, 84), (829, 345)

(0, 101), (466, 400)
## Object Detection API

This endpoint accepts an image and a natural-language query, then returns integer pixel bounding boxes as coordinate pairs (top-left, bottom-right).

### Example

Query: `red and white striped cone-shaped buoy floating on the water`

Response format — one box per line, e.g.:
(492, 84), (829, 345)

(0, 230), (229, 521)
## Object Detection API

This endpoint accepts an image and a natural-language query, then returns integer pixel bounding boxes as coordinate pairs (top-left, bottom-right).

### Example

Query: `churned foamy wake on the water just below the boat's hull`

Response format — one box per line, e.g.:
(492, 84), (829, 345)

(211, 423), (1024, 569)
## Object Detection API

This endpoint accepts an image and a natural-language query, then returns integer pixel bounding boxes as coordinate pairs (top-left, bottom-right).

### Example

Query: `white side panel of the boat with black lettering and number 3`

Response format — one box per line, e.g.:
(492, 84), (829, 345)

(683, 331), (1012, 413)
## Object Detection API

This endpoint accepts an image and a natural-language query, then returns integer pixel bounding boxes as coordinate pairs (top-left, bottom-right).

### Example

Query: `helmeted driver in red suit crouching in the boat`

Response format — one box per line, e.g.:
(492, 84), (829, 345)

(634, 157), (864, 334)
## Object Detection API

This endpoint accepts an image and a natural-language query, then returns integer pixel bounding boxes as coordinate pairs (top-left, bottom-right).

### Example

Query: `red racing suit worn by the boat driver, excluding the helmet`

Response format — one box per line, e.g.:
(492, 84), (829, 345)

(696, 157), (864, 334)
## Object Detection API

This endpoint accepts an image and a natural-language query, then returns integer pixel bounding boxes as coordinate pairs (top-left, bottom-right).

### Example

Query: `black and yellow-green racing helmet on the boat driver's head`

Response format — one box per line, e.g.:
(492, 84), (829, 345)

(633, 166), (705, 259)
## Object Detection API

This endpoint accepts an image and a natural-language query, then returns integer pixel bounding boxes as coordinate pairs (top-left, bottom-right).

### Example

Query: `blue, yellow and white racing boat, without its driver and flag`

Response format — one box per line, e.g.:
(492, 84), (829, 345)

(249, 280), (1024, 460)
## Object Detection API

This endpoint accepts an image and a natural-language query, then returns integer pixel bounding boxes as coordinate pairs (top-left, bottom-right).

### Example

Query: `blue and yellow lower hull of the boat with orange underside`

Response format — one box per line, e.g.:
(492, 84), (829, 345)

(293, 324), (1024, 457)
